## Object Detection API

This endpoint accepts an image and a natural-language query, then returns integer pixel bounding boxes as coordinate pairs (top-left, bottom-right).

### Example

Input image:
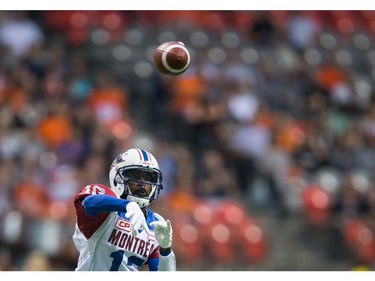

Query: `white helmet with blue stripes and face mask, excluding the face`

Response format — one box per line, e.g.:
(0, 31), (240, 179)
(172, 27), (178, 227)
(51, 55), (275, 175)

(109, 148), (163, 208)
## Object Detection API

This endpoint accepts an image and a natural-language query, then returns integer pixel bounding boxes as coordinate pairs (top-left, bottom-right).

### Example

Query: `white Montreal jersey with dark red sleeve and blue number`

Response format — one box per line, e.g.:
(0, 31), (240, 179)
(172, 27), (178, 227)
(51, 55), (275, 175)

(73, 184), (159, 271)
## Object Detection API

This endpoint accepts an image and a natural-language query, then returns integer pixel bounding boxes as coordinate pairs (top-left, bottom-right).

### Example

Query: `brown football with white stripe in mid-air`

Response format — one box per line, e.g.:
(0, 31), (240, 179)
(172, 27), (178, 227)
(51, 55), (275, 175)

(154, 41), (190, 76)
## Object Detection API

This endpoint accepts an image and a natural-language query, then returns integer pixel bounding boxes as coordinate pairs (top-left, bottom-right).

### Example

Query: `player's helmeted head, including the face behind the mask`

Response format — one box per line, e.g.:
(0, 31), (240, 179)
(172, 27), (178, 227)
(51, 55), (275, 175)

(109, 148), (163, 208)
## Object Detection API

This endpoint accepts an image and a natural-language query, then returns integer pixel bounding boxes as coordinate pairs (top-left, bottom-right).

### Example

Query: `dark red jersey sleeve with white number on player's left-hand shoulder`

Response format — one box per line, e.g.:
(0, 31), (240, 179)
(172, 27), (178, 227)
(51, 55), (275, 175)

(74, 184), (117, 239)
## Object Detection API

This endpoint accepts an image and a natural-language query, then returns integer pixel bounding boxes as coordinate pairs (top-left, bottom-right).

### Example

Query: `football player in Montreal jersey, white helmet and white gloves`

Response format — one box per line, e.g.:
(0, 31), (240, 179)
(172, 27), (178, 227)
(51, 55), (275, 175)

(73, 148), (176, 271)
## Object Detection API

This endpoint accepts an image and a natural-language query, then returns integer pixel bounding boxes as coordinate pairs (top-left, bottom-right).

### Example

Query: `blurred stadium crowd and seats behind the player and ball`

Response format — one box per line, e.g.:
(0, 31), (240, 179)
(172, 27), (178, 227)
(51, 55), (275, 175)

(0, 10), (375, 271)
